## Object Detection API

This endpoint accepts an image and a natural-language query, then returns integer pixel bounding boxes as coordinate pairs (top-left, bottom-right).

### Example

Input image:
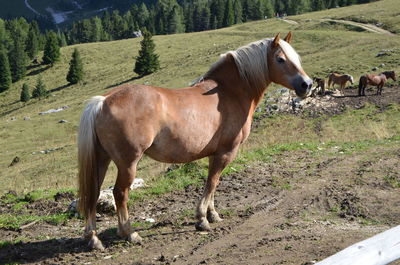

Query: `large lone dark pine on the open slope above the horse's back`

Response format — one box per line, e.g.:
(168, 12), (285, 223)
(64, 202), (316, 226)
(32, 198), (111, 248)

(133, 31), (160, 76)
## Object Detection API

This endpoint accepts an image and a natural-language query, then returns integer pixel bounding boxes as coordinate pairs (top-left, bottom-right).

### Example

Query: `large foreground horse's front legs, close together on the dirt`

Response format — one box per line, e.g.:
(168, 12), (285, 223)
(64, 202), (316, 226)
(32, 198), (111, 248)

(196, 151), (237, 231)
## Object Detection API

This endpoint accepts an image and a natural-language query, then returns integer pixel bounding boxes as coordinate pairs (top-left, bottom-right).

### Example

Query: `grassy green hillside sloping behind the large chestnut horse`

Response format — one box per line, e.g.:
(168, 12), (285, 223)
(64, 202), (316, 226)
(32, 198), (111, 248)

(0, 0), (400, 193)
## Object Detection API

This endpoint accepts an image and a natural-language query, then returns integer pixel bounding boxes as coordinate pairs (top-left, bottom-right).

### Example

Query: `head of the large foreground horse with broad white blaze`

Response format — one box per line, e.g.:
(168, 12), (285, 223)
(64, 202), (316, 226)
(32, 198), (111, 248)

(268, 32), (313, 98)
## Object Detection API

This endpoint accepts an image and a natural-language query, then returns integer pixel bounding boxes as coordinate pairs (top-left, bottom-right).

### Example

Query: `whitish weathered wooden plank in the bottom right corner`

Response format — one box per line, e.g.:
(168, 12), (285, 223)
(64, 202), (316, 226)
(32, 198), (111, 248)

(316, 226), (400, 265)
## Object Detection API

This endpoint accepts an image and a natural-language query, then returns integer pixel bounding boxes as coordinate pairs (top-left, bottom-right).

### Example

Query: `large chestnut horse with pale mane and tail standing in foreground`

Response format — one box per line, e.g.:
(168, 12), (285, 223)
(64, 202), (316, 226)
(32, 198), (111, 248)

(78, 32), (312, 249)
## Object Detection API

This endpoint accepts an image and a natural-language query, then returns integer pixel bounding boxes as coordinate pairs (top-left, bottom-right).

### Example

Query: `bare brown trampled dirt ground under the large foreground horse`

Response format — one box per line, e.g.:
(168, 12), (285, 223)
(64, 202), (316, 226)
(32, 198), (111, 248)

(0, 87), (400, 264)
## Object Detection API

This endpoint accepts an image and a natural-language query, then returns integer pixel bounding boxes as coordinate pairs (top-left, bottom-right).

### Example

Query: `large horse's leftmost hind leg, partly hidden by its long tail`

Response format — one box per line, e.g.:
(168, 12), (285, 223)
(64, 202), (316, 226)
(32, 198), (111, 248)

(85, 150), (110, 250)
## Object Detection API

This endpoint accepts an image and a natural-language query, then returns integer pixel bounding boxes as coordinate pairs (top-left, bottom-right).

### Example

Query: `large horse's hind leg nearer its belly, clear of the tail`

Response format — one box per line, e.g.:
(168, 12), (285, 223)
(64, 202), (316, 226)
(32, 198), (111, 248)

(113, 155), (142, 243)
